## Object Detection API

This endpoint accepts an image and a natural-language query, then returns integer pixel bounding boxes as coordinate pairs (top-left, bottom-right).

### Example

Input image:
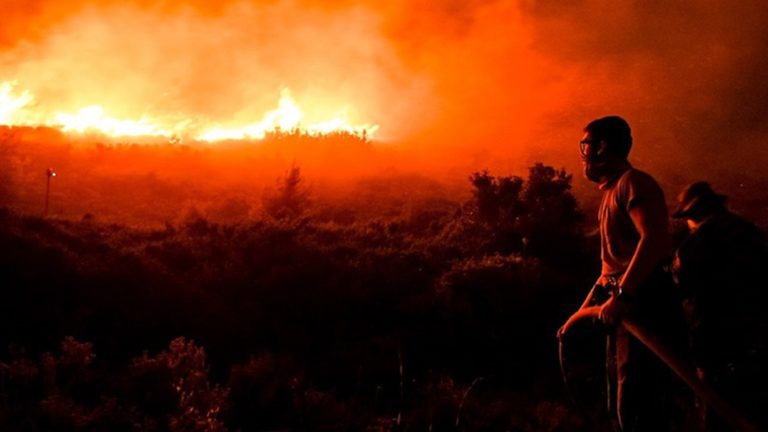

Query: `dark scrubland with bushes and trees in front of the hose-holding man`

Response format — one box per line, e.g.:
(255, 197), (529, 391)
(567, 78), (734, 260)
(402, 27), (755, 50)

(0, 164), (598, 431)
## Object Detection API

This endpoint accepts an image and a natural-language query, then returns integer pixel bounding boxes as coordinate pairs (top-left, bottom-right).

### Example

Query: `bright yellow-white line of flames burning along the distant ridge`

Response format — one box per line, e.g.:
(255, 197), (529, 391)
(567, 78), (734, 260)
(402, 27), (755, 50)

(0, 82), (379, 142)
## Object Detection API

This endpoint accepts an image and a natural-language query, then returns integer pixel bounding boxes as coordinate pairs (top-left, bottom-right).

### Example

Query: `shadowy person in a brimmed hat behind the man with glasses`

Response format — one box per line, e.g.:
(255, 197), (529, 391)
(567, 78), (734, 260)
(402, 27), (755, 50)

(672, 182), (768, 431)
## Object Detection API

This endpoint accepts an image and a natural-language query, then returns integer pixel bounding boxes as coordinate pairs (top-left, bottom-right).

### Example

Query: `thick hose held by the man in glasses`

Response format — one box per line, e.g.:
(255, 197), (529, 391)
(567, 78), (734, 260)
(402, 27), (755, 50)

(560, 306), (759, 432)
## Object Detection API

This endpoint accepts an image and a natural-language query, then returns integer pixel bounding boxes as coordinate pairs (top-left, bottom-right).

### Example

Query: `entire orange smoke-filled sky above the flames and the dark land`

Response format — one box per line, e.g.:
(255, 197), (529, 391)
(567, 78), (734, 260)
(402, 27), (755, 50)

(0, 0), (768, 201)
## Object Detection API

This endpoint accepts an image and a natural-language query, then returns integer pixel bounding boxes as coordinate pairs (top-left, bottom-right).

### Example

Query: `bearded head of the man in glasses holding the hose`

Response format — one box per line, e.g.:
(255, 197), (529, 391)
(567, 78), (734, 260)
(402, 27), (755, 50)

(579, 116), (632, 182)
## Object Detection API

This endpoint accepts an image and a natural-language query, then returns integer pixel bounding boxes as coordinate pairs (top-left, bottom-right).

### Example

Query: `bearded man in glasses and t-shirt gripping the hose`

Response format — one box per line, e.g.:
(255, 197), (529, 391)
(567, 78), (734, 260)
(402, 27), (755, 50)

(574, 116), (685, 432)
